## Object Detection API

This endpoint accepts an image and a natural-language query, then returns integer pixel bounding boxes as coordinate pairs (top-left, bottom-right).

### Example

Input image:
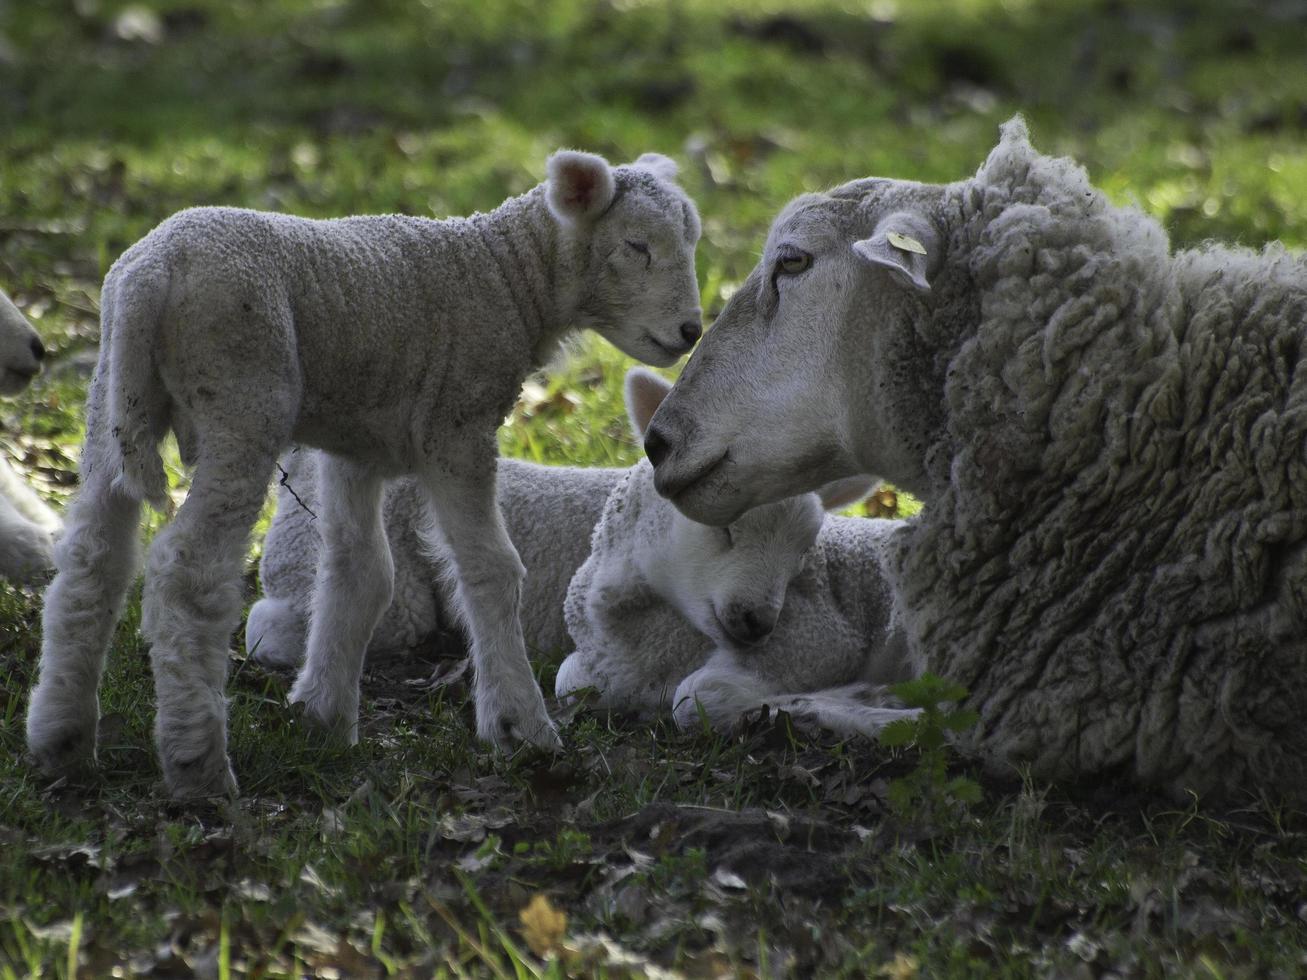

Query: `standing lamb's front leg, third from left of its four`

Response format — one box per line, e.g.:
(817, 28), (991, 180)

(290, 453), (395, 745)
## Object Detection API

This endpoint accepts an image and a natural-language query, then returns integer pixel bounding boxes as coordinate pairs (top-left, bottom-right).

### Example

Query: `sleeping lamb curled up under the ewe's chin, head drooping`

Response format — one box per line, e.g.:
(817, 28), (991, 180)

(554, 371), (915, 734)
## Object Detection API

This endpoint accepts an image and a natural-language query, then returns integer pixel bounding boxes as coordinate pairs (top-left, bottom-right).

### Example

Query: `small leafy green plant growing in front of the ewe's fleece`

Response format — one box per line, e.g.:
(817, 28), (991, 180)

(881, 674), (980, 818)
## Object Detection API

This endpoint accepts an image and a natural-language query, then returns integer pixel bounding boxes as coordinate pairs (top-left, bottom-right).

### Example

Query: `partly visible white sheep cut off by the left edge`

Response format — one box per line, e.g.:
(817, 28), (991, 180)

(0, 291), (60, 584)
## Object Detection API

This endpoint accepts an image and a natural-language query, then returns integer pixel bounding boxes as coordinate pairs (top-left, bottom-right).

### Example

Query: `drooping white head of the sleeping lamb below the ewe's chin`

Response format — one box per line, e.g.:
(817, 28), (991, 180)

(626, 368), (872, 648)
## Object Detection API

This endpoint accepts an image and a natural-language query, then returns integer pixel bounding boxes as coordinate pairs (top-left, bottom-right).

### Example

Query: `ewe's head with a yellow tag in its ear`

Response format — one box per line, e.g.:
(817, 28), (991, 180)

(644, 167), (967, 525)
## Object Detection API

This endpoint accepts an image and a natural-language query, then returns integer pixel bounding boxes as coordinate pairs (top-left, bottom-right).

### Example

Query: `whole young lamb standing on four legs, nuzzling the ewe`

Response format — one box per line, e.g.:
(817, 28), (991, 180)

(27, 152), (701, 798)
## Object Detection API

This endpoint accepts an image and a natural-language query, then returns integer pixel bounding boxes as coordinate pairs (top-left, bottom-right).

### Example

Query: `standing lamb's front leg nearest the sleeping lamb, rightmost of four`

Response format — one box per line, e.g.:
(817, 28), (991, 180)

(423, 456), (561, 749)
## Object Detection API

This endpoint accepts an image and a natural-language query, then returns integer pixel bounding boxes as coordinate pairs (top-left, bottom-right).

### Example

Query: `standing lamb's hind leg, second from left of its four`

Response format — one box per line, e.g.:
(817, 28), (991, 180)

(141, 449), (278, 798)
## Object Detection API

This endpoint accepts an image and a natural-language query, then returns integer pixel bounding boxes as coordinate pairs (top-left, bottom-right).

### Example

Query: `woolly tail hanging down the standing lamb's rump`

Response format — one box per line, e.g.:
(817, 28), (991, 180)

(101, 256), (171, 511)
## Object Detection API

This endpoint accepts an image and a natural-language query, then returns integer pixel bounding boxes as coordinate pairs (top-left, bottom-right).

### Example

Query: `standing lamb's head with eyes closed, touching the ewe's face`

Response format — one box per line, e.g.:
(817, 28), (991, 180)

(546, 150), (702, 366)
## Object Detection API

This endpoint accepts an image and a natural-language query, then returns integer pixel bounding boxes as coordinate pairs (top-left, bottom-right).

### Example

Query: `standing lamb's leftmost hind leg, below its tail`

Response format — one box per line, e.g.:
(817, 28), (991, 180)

(27, 374), (141, 772)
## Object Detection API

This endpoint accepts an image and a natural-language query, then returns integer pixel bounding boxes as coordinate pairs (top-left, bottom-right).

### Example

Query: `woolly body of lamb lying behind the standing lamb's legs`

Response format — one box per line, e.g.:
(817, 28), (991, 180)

(246, 449), (626, 666)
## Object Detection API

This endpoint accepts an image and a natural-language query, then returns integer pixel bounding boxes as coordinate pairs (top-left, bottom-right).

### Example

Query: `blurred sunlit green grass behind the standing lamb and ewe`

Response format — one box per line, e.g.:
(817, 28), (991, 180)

(0, 0), (1307, 494)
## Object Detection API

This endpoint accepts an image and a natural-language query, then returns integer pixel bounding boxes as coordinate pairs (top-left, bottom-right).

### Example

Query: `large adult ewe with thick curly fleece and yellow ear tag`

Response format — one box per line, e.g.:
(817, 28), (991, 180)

(646, 118), (1307, 804)
